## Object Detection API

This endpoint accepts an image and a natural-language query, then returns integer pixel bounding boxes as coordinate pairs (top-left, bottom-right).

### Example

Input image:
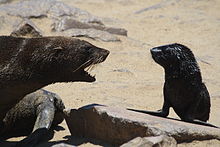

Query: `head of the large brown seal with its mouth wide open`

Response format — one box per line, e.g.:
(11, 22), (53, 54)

(17, 37), (109, 82)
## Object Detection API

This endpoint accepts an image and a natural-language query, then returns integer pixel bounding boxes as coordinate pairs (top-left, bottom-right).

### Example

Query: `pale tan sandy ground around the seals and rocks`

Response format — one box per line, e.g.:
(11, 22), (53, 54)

(0, 0), (220, 146)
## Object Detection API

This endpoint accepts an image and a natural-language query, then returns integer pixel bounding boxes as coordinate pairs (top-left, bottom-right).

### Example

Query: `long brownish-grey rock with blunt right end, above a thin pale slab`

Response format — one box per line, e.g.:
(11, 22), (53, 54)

(53, 17), (127, 36)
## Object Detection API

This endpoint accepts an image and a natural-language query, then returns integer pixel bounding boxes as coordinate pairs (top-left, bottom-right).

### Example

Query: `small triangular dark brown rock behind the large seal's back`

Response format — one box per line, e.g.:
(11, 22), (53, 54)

(11, 20), (43, 37)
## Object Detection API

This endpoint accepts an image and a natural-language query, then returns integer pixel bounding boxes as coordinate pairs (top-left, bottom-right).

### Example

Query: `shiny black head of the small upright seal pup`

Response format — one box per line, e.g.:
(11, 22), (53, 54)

(150, 43), (200, 80)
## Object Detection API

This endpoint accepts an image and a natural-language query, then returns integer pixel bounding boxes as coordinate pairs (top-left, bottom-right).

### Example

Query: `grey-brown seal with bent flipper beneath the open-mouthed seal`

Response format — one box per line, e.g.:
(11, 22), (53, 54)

(0, 89), (65, 142)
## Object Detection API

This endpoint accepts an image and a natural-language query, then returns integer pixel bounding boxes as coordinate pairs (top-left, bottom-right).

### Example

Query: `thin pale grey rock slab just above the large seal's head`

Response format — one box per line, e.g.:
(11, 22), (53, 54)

(61, 29), (120, 42)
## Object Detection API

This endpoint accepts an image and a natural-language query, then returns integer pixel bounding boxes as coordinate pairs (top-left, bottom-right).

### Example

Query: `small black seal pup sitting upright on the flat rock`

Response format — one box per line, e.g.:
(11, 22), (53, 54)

(129, 43), (216, 127)
